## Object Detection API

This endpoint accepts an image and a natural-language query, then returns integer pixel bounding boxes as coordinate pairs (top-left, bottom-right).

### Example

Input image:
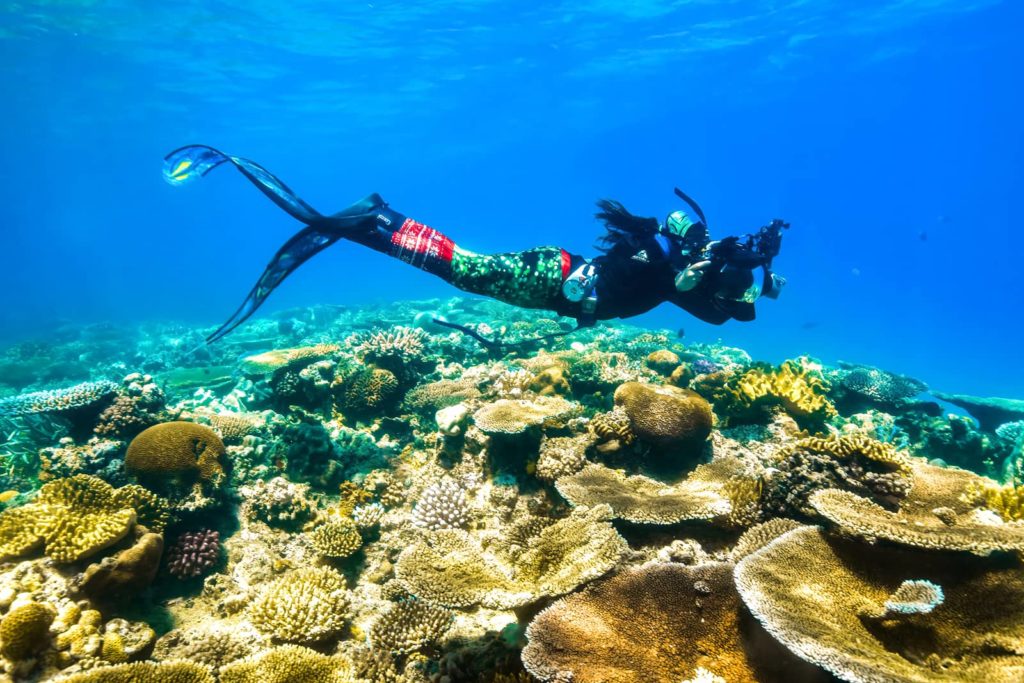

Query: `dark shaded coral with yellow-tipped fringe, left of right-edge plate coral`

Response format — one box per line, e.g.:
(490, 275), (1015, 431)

(764, 433), (913, 516)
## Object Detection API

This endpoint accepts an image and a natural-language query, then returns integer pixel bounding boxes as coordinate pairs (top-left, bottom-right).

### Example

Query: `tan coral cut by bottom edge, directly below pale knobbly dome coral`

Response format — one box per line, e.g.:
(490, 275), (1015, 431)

(219, 645), (356, 683)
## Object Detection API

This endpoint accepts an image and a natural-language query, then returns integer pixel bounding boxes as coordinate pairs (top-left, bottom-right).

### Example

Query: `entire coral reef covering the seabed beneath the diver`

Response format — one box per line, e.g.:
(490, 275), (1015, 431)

(0, 299), (1024, 683)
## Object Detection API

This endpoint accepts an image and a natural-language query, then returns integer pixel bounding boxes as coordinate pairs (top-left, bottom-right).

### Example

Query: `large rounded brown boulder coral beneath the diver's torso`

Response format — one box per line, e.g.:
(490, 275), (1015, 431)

(614, 382), (714, 447)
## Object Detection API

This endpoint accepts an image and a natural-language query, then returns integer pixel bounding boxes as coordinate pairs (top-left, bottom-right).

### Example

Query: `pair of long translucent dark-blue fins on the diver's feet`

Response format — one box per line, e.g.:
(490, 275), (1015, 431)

(164, 144), (386, 343)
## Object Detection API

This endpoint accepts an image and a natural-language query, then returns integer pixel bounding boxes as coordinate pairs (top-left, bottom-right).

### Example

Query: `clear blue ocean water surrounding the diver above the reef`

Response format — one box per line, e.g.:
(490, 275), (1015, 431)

(0, 0), (1024, 396)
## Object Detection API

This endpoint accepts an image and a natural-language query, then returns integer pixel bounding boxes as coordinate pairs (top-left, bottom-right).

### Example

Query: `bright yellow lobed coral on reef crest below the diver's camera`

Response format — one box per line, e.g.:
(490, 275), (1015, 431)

(732, 360), (836, 418)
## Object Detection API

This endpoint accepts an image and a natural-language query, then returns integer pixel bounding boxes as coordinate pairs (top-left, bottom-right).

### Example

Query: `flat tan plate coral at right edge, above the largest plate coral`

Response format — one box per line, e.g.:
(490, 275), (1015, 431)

(810, 488), (1024, 554)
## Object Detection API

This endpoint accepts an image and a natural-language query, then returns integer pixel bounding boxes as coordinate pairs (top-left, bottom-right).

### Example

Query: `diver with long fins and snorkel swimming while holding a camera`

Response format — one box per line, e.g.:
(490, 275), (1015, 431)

(164, 145), (790, 343)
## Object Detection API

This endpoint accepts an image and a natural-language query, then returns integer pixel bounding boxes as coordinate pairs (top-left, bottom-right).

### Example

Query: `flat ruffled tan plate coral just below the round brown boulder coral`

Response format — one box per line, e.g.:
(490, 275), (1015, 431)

(555, 463), (730, 524)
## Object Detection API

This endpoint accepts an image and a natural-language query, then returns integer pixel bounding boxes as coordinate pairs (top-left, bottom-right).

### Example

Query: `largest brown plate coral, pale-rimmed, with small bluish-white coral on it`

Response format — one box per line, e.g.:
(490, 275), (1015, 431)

(735, 526), (1024, 683)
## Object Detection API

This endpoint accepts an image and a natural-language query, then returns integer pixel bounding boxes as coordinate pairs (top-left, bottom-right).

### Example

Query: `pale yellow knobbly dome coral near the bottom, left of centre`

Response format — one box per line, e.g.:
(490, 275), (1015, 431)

(249, 567), (348, 643)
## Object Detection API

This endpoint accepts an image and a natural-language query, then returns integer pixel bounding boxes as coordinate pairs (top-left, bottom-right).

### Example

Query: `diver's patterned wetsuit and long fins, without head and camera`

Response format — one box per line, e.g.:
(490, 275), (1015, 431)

(164, 145), (754, 341)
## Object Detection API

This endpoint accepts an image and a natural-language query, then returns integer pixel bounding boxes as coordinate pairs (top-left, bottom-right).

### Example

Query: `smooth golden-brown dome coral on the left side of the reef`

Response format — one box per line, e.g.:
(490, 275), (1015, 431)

(125, 422), (224, 485)
